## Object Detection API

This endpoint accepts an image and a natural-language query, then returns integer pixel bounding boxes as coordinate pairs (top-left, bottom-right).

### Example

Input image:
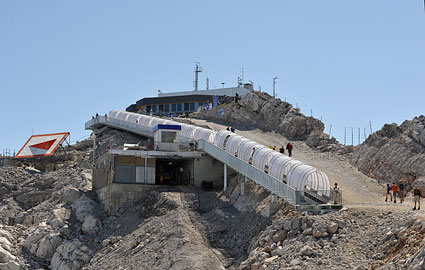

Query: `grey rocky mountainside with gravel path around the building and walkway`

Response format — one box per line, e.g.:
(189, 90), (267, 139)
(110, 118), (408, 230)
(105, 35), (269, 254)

(0, 93), (425, 270)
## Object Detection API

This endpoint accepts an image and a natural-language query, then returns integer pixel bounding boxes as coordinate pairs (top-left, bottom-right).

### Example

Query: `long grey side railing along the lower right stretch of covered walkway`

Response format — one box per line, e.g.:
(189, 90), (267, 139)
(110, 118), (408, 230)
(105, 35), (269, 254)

(199, 140), (301, 205)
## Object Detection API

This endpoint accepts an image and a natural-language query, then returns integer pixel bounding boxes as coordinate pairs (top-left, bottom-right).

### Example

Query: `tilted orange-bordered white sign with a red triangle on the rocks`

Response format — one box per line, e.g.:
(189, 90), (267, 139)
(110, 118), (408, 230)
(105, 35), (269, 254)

(15, 132), (69, 158)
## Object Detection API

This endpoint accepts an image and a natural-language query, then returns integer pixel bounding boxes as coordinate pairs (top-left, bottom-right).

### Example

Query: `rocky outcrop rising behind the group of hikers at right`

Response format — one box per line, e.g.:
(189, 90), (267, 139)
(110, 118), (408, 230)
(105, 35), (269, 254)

(352, 115), (425, 190)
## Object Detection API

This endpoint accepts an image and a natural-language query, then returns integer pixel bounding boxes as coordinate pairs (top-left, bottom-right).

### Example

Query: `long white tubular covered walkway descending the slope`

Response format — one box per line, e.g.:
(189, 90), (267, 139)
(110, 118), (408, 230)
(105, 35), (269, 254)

(86, 110), (341, 209)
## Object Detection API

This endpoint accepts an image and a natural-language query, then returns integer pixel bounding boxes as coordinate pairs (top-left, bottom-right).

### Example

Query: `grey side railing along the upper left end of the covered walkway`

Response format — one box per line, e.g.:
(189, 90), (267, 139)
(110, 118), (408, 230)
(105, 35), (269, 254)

(85, 115), (153, 138)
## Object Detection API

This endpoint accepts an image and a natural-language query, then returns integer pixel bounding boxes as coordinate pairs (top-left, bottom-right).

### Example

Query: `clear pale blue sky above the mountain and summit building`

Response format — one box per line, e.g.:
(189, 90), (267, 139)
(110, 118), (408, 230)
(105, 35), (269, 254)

(0, 0), (425, 154)
